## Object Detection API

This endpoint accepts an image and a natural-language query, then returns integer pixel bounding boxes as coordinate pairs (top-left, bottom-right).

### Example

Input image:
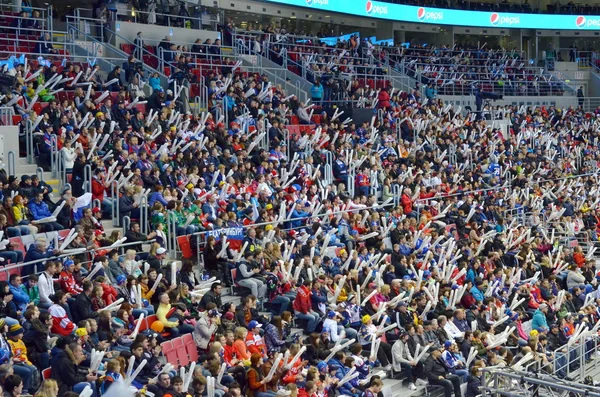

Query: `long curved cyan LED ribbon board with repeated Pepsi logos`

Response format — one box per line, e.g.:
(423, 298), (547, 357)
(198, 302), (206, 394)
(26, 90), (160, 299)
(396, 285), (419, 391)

(265, 0), (600, 30)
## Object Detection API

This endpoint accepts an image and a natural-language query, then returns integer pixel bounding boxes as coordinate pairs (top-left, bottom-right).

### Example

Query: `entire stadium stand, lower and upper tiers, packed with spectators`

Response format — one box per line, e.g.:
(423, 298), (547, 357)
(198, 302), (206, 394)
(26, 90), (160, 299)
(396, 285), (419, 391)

(0, 0), (600, 397)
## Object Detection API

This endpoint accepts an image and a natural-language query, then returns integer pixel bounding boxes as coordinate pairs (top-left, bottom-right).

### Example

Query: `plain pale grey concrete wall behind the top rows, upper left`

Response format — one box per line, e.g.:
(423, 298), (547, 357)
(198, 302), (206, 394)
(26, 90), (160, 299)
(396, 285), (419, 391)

(111, 22), (219, 48)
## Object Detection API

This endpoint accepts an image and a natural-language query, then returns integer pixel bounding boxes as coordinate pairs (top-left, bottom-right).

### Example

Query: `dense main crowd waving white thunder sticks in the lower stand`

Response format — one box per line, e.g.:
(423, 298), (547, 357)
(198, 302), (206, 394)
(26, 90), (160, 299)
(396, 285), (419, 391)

(0, 35), (600, 397)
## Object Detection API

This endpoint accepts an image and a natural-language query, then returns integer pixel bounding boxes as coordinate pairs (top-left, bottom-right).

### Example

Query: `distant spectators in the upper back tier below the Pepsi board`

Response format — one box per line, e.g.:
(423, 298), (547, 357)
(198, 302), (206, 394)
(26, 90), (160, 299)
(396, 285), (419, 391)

(237, 26), (565, 99)
